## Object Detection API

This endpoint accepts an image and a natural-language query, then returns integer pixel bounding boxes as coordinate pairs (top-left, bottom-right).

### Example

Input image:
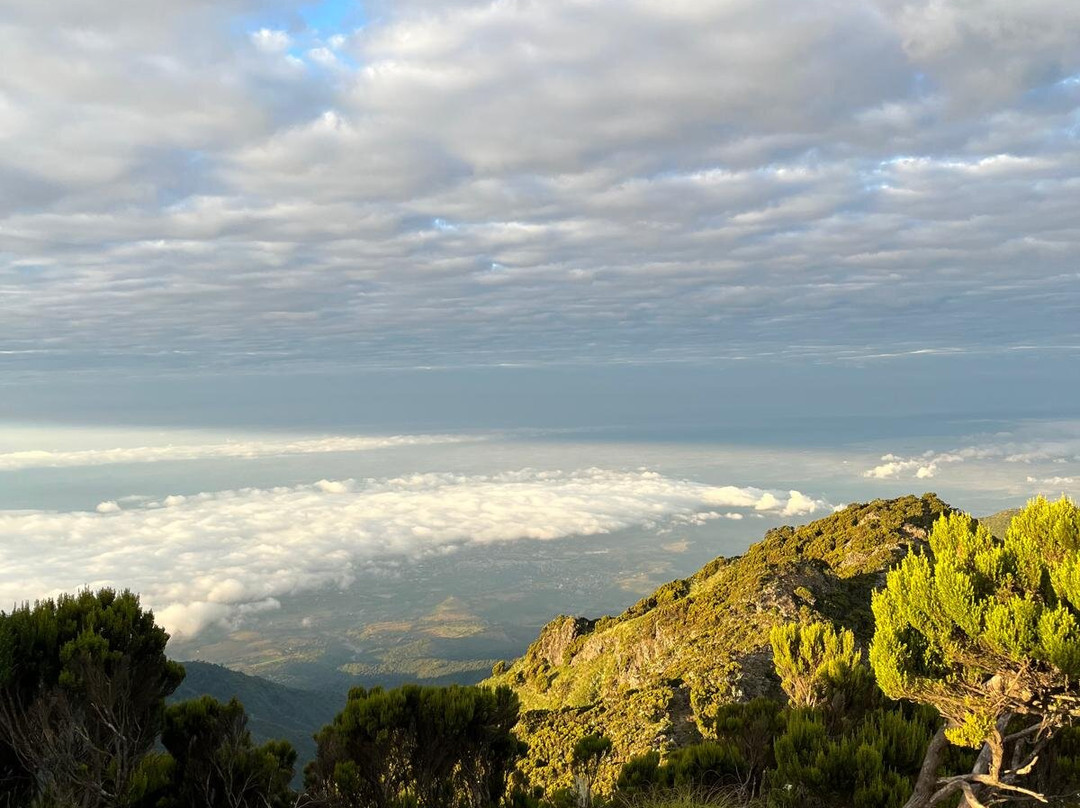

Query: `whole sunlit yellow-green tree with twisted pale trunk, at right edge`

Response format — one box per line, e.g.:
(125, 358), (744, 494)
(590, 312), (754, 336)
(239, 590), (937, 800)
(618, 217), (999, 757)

(869, 497), (1080, 808)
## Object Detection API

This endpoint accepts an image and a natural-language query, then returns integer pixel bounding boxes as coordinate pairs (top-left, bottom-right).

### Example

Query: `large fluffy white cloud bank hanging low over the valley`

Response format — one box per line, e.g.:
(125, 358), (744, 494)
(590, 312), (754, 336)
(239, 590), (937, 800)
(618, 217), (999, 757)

(0, 469), (824, 637)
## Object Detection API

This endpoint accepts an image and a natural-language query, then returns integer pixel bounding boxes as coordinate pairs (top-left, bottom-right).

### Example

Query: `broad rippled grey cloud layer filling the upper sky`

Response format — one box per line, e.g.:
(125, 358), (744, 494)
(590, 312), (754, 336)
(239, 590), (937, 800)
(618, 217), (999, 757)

(0, 0), (1080, 371)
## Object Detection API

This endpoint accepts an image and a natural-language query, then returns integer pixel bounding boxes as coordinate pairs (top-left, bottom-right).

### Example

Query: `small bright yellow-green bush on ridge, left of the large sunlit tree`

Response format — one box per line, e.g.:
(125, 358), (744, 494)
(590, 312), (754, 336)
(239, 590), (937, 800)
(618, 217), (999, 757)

(769, 622), (877, 712)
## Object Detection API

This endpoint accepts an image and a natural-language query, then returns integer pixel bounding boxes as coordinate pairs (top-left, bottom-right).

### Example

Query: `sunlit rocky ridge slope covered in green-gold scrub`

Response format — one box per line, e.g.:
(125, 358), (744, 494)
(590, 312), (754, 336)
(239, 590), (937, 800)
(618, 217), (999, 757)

(488, 494), (950, 787)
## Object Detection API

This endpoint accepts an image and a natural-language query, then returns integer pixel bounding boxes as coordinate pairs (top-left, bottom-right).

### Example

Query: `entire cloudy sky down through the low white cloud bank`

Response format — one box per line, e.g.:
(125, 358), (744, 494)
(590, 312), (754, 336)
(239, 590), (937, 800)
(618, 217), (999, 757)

(0, 0), (1080, 648)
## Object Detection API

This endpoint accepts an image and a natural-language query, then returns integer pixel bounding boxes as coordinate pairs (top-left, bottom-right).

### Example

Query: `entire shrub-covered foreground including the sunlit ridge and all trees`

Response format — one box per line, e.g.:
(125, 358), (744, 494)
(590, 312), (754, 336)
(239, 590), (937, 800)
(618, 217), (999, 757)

(6, 495), (1080, 808)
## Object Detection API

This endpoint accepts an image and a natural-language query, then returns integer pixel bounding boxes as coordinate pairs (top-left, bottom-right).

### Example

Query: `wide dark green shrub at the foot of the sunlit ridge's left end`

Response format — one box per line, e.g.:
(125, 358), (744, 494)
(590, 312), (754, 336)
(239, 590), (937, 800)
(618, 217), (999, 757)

(306, 685), (524, 808)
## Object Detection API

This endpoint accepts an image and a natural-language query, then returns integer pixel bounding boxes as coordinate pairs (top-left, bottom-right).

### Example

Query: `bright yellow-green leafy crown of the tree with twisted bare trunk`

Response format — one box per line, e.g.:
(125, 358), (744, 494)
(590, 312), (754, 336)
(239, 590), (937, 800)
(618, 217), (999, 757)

(869, 497), (1080, 745)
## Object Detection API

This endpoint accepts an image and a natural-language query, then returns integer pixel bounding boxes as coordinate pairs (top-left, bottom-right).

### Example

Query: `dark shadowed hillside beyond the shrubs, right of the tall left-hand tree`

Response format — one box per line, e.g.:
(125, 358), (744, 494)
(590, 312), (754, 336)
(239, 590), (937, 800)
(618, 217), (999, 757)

(170, 662), (346, 772)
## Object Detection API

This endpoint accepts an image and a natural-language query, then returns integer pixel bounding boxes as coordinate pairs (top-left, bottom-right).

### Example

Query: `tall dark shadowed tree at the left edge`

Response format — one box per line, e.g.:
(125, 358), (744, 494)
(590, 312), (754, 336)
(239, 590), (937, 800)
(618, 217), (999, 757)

(0, 589), (184, 808)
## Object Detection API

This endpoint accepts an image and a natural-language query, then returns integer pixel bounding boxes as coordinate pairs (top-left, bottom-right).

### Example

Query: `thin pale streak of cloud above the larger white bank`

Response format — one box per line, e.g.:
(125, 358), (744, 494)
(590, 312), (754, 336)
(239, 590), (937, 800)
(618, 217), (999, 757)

(0, 434), (486, 470)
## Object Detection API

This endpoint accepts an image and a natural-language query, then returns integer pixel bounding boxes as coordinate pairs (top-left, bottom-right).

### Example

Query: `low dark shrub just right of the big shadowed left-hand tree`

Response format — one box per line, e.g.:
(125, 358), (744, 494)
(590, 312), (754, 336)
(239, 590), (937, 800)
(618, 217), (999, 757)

(156, 696), (296, 808)
